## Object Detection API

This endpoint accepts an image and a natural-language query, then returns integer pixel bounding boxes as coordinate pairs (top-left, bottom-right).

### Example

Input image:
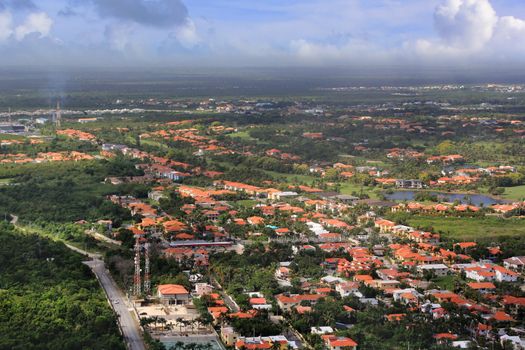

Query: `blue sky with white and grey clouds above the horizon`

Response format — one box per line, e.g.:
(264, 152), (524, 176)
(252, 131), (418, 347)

(0, 0), (525, 67)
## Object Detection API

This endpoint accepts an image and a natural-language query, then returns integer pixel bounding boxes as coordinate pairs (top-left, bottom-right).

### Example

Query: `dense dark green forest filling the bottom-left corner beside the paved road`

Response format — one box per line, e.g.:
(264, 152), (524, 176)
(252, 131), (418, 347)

(0, 223), (125, 350)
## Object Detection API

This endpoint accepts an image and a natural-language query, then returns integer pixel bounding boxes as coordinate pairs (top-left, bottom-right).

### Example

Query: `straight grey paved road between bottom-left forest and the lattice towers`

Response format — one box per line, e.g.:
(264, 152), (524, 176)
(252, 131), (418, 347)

(84, 258), (146, 350)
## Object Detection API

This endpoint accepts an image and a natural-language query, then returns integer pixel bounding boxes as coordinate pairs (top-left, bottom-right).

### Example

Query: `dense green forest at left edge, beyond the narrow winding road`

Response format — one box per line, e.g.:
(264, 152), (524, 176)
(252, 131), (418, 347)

(0, 158), (139, 226)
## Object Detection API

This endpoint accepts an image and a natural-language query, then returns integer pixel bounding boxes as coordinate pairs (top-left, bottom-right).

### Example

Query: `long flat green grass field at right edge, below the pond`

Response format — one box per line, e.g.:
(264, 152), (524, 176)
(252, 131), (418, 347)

(408, 216), (525, 240)
